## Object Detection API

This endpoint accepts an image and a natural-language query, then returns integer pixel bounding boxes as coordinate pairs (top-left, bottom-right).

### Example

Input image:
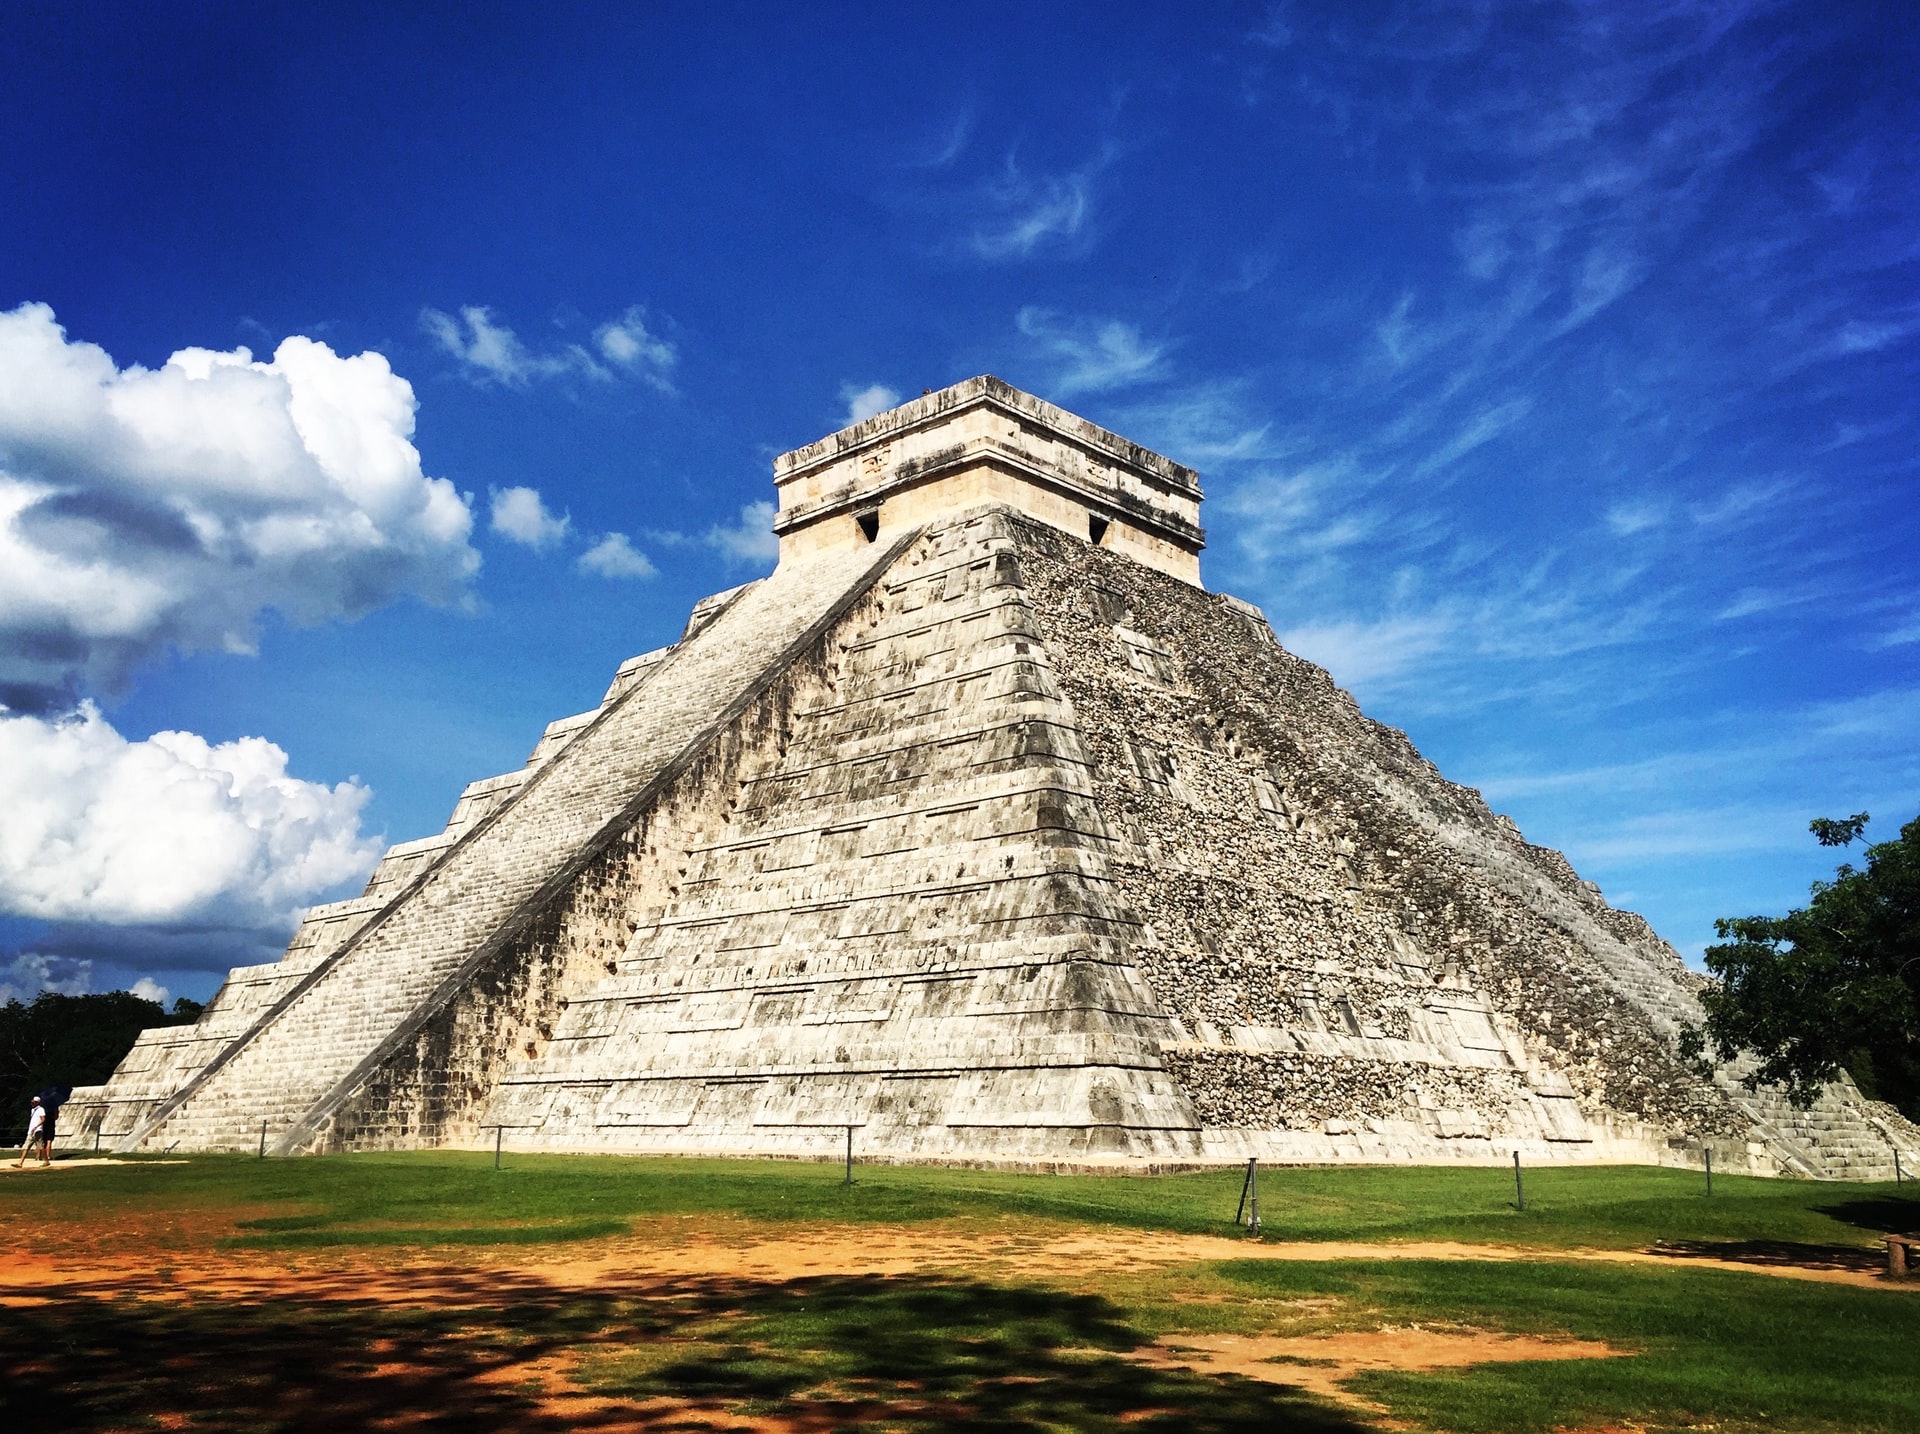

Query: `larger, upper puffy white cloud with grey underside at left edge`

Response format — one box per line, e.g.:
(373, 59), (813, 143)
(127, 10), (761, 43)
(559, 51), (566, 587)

(0, 303), (480, 712)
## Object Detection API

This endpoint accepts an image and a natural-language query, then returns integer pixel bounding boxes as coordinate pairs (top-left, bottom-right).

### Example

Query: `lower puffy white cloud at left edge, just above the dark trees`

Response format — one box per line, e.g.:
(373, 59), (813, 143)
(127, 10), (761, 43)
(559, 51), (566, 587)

(0, 703), (380, 929)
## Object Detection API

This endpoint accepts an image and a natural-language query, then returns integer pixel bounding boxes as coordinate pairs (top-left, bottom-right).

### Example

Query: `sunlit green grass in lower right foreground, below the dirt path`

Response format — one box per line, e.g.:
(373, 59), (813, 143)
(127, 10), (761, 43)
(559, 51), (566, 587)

(1219, 1259), (1920, 1434)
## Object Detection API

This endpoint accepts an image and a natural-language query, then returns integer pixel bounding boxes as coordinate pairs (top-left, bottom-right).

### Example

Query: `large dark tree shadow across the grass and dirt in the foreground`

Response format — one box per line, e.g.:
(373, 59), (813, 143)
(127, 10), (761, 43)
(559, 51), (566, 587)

(0, 1269), (1367, 1434)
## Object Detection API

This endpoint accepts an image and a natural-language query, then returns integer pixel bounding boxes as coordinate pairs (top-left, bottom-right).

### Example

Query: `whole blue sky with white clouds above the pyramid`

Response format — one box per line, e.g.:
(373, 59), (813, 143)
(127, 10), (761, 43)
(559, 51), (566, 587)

(0, 4), (1920, 996)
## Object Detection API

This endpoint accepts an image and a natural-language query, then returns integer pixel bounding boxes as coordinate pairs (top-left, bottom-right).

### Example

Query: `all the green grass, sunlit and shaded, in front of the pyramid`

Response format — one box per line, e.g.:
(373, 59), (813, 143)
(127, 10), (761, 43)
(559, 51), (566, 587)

(0, 1152), (1920, 1434)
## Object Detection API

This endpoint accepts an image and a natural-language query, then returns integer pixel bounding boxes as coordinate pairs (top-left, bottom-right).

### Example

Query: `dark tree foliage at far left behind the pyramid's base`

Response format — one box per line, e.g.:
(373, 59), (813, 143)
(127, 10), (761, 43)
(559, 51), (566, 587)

(0, 991), (202, 1140)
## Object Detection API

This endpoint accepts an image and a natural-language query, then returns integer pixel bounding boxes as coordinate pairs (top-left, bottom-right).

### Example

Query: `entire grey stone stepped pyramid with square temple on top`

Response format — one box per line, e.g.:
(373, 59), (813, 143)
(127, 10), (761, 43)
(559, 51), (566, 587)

(61, 378), (1920, 1179)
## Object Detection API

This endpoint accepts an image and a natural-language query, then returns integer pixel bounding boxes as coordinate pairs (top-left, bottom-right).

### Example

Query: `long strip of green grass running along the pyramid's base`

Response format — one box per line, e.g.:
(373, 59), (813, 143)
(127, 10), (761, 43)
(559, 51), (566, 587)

(0, 1152), (1920, 1254)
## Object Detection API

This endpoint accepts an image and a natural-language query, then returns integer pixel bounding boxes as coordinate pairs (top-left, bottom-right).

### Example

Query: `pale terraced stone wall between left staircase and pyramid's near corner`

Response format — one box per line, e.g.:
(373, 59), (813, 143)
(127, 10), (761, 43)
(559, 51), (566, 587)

(460, 513), (1198, 1158)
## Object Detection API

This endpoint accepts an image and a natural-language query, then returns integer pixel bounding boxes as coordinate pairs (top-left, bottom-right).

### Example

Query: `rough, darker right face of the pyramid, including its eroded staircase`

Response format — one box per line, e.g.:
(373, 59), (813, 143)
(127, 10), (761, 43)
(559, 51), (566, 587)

(1016, 518), (1920, 1179)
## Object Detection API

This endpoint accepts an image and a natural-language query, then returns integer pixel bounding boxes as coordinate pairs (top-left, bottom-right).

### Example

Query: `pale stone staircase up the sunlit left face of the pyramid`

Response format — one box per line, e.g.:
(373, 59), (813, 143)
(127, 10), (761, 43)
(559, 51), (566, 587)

(109, 539), (906, 1154)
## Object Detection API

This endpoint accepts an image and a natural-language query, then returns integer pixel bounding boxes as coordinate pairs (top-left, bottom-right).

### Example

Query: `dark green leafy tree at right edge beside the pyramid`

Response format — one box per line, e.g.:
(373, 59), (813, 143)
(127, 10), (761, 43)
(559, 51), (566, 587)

(1682, 812), (1920, 1115)
